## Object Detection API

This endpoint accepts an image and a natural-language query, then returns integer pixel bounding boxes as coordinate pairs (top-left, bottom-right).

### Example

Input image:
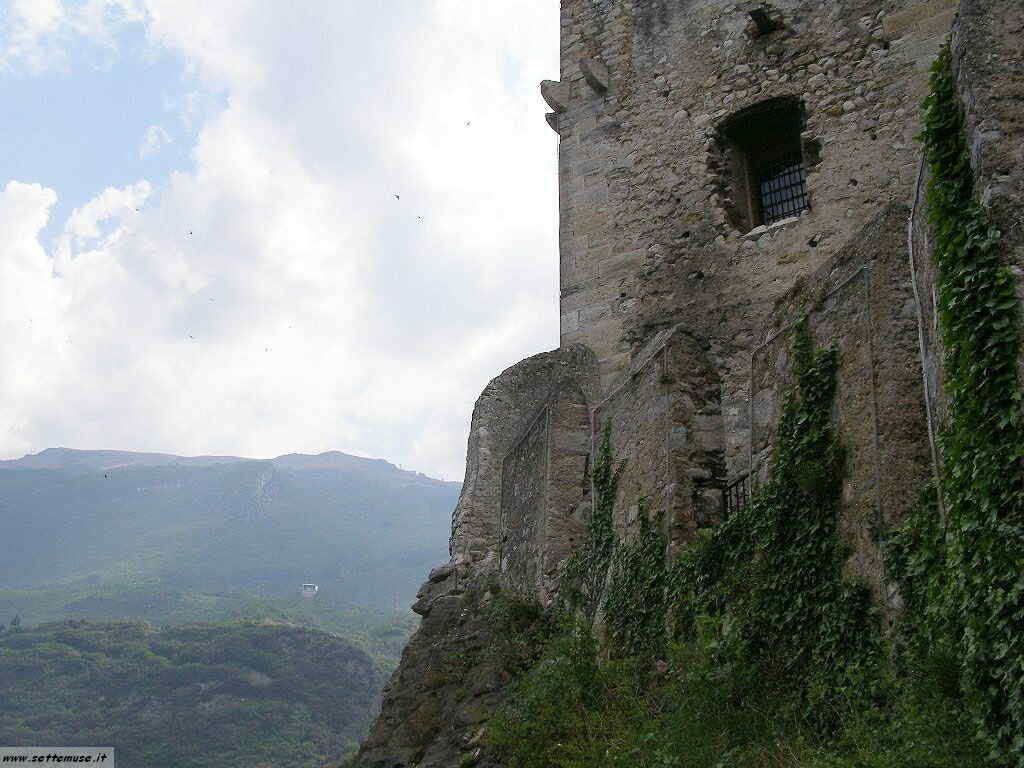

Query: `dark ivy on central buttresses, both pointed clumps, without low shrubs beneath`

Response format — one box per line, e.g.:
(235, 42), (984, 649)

(563, 318), (881, 708)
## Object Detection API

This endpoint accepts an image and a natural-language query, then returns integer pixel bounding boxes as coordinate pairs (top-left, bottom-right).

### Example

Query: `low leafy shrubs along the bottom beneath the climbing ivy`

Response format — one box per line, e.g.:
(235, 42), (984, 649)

(487, 625), (981, 768)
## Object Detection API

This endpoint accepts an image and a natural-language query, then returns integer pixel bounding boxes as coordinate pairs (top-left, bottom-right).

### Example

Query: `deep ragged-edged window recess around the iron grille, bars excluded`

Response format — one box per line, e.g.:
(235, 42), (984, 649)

(708, 95), (820, 233)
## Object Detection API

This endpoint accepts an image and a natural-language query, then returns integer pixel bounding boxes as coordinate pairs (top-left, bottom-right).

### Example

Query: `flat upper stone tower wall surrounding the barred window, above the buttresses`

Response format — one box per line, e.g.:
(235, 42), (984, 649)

(546, 0), (954, 476)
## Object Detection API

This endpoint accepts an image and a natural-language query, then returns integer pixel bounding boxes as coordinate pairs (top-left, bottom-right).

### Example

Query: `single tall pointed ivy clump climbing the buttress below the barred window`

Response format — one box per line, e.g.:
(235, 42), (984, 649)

(669, 318), (881, 698)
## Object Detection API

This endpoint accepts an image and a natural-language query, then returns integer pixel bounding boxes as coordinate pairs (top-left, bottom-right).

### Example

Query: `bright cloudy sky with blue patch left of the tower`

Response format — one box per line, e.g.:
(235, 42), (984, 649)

(0, 0), (558, 479)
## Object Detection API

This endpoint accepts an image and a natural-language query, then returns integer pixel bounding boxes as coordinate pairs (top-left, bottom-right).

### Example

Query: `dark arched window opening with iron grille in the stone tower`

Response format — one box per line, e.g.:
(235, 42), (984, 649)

(713, 98), (810, 232)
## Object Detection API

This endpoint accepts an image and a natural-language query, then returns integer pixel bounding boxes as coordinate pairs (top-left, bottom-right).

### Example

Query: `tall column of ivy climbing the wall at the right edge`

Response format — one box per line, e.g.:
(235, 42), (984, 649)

(889, 45), (1024, 768)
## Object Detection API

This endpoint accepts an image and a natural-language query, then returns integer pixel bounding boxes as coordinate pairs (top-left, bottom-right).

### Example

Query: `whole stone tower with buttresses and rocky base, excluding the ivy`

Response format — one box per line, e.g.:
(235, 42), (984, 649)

(356, 0), (1024, 768)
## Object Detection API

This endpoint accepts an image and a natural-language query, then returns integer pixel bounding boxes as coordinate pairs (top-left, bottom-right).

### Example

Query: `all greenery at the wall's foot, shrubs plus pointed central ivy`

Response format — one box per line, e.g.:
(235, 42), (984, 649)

(487, 324), (983, 768)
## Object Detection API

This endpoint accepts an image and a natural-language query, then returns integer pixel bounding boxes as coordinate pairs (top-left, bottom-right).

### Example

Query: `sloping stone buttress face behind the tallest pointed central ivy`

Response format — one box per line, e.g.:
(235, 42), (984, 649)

(751, 204), (932, 605)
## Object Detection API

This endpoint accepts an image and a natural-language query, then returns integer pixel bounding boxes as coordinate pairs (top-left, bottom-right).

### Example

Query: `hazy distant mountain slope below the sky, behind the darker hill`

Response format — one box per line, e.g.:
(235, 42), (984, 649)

(0, 452), (459, 667)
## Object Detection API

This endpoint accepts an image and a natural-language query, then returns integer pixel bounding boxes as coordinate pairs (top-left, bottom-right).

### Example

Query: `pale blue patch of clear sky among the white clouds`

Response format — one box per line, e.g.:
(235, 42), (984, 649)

(0, 25), (223, 245)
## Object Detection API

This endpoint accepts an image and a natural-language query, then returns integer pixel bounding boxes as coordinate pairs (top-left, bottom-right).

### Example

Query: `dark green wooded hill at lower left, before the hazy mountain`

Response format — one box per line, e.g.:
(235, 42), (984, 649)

(0, 621), (383, 768)
